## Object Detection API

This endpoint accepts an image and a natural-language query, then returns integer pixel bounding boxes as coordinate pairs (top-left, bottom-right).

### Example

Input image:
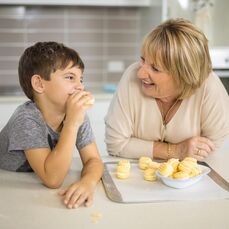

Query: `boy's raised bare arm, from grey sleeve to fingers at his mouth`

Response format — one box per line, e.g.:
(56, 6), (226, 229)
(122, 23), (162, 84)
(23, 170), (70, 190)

(25, 91), (91, 188)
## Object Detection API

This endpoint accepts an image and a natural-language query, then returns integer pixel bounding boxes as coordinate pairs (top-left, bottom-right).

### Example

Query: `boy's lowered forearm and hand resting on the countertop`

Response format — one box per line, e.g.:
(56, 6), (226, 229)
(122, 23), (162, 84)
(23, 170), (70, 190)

(59, 142), (103, 208)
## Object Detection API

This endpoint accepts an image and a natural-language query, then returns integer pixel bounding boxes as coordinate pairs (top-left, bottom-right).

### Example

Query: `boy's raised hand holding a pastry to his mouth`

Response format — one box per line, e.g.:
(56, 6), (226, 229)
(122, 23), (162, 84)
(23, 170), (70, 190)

(65, 90), (94, 126)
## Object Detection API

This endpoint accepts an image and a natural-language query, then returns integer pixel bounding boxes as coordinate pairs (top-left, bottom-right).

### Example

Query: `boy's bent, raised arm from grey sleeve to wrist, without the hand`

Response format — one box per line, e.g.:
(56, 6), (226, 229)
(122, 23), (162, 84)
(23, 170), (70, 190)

(25, 120), (78, 188)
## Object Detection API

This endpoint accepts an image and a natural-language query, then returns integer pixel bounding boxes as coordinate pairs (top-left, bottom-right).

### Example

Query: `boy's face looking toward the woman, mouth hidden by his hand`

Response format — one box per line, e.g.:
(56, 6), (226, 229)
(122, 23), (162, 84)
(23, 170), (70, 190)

(43, 63), (84, 108)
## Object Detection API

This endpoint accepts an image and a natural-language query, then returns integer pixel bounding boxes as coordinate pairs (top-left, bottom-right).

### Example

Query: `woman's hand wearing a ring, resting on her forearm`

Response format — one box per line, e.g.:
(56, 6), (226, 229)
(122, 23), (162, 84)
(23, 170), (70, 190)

(176, 137), (215, 161)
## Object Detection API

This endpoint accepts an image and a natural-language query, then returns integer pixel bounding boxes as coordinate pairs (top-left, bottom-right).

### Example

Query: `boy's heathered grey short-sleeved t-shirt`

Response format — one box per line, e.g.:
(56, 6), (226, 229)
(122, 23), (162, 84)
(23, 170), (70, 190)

(0, 101), (95, 172)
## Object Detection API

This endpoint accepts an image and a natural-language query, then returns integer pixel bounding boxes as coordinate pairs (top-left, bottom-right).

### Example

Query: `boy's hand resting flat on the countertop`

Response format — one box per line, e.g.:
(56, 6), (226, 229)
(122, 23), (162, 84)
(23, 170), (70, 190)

(58, 179), (96, 209)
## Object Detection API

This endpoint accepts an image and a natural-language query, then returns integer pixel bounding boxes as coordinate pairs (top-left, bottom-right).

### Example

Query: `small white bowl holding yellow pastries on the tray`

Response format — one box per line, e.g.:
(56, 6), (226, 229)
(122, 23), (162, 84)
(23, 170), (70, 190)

(155, 165), (211, 188)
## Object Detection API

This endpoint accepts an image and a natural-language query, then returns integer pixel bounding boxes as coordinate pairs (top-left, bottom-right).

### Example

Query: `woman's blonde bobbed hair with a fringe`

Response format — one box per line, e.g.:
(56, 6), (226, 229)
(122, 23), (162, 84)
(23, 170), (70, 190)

(142, 18), (212, 99)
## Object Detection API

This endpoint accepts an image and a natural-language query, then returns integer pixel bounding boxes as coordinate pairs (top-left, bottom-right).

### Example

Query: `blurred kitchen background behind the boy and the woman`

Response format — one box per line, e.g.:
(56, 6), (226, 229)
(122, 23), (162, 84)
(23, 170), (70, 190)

(0, 0), (229, 154)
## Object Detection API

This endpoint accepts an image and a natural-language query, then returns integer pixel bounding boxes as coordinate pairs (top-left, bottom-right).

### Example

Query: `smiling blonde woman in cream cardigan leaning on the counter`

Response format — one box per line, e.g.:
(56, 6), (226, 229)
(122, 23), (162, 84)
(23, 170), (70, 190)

(105, 19), (229, 160)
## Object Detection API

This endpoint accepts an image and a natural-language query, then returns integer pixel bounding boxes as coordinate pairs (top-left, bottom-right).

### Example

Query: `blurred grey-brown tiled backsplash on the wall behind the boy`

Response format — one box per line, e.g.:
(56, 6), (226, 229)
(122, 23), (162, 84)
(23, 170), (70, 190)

(0, 6), (161, 94)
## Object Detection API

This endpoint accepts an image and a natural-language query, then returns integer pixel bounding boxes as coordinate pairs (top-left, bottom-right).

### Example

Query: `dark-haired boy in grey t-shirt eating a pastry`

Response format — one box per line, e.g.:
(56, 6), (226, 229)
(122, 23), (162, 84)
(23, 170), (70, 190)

(0, 42), (103, 208)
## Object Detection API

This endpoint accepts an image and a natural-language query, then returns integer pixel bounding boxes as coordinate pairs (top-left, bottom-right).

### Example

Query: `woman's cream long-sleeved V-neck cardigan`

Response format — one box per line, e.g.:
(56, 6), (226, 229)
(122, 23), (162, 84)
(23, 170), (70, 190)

(105, 63), (229, 158)
